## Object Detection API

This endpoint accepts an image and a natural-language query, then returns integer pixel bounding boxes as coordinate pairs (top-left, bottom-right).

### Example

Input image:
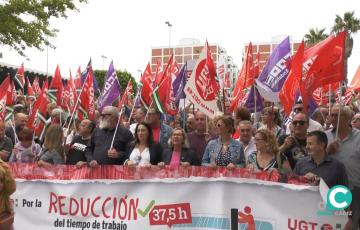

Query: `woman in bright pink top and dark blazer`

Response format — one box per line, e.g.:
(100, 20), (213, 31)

(158, 128), (195, 166)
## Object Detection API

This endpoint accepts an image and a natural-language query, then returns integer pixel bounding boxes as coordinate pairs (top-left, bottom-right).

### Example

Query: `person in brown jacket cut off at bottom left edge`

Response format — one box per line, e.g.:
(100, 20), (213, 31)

(0, 159), (16, 230)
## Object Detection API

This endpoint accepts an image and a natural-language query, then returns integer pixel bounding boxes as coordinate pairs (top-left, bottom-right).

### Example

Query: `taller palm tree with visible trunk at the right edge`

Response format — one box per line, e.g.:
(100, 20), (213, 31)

(331, 12), (360, 84)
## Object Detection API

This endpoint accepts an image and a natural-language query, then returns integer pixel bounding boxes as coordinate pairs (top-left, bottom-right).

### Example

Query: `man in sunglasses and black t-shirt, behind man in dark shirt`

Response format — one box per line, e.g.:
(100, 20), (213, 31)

(278, 112), (309, 169)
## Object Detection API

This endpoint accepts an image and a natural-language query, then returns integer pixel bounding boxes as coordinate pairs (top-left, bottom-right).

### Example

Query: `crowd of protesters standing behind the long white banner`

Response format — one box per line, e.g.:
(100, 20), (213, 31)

(0, 92), (360, 229)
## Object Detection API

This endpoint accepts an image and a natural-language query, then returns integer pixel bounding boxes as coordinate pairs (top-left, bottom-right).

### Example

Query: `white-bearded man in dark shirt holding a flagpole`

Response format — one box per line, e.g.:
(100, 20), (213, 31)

(85, 106), (133, 167)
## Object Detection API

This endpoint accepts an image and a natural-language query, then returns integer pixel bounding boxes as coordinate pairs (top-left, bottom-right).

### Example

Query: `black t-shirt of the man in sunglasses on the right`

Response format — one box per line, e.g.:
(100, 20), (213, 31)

(278, 135), (308, 170)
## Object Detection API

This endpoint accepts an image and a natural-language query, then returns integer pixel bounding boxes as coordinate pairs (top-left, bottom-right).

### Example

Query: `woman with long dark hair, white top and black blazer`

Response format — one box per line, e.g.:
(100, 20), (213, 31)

(124, 122), (162, 166)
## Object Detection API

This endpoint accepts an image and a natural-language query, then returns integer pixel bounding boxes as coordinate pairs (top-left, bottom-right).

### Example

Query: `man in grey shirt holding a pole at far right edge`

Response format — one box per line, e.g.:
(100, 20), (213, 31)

(326, 105), (360, 229)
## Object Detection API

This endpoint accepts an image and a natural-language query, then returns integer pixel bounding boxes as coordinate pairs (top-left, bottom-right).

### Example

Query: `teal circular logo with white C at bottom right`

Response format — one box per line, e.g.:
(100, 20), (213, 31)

(318, 185), (352, 216)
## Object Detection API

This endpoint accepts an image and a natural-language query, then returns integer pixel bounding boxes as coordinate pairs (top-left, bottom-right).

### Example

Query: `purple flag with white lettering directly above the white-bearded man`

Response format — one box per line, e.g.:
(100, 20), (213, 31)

(97, 61), (121, 112)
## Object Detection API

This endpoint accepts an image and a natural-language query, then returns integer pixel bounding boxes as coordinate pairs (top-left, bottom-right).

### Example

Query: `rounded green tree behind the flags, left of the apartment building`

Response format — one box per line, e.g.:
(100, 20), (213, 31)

(94, 70), (137, 93)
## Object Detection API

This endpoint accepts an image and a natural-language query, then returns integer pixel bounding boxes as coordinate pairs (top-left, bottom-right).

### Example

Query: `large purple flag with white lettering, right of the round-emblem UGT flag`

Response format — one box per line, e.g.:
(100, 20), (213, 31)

(256, 37), (291, 102)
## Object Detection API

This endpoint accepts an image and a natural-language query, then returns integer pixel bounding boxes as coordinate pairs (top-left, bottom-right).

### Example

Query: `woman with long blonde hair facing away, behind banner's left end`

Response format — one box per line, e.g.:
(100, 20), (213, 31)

(37, 125), (65, 166)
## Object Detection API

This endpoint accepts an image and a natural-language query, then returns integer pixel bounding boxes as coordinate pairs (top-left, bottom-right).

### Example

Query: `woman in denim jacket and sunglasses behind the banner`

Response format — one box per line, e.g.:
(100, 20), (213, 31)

(202, 116), (245, 168)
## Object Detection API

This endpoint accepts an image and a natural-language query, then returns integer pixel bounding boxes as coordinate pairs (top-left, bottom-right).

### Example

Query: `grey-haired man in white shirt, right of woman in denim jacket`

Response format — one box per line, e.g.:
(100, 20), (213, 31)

(238, 120), (256, 161)
